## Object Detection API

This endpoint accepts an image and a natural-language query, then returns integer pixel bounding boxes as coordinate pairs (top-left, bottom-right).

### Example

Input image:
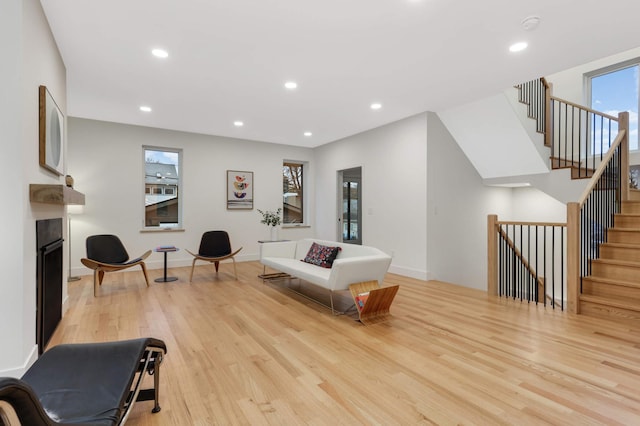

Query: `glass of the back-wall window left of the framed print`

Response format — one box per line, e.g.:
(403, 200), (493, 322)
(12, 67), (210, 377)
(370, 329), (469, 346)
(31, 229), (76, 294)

(144, 149), (180, 227)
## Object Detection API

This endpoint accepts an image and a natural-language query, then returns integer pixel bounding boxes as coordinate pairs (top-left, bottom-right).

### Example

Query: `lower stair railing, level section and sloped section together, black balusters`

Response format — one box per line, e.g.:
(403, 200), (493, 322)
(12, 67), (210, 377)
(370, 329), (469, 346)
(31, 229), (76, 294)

(487, 108), (629, 313)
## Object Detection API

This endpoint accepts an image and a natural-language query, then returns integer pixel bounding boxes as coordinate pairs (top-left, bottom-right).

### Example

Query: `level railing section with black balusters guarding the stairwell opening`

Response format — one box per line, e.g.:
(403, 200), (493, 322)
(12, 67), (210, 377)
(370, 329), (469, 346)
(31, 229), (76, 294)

(488, 215), (567, 309)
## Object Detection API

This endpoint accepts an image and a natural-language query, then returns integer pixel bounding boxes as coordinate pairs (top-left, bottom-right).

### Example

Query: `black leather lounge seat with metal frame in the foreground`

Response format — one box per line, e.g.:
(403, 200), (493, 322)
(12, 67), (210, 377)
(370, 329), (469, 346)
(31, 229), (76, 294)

(0, 337), (167, 426)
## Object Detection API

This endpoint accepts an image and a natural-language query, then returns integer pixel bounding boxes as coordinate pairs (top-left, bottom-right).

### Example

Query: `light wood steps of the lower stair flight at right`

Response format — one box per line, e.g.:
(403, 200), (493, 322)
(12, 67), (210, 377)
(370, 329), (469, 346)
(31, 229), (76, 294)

(580, 201), (640, 320)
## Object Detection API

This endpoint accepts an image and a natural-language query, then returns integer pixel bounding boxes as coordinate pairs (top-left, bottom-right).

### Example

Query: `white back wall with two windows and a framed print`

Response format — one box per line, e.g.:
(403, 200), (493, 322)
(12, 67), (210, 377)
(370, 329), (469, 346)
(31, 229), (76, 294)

(68, 118), (315, 275)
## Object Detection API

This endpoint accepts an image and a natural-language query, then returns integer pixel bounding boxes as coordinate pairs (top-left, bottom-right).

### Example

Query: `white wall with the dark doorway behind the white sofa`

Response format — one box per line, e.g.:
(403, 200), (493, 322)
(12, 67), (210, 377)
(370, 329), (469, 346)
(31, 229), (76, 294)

(316, 114), (427, 279)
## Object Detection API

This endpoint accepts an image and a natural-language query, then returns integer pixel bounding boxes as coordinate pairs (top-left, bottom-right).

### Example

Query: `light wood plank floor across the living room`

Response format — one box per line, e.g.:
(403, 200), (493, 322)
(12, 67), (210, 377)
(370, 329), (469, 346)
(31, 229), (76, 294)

(51, 262), (640, 425)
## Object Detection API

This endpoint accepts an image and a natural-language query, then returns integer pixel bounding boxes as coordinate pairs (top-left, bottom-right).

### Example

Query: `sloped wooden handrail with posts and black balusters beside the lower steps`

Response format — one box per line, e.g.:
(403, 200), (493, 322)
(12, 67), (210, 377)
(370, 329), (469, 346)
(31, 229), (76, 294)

(567, 112), (629, 313)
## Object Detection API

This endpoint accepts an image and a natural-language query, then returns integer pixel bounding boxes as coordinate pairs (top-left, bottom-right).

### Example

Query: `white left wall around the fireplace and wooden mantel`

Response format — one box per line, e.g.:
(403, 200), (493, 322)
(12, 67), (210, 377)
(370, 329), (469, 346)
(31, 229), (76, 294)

(0, 0), (66, 376)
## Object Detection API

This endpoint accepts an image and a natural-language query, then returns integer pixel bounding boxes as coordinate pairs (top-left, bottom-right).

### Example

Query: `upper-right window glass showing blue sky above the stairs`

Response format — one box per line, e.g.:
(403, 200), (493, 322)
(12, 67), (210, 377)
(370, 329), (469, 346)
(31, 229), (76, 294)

(591, 65), (640, 153)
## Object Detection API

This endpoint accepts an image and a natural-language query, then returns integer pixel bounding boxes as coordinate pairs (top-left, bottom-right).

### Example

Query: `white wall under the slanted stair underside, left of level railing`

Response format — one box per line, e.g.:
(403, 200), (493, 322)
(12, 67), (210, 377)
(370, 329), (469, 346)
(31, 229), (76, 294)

(427, 113), (512, 290)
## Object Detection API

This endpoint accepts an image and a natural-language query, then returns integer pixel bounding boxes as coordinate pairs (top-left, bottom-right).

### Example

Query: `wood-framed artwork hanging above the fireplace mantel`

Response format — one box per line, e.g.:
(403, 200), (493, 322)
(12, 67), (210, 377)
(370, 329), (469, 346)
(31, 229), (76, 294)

(39, 86), (64, 175)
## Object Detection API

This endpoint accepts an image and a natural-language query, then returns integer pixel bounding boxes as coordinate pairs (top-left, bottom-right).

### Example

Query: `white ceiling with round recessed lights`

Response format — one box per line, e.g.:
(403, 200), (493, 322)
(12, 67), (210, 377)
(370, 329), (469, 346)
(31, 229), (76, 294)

(41, 0), (640, 147)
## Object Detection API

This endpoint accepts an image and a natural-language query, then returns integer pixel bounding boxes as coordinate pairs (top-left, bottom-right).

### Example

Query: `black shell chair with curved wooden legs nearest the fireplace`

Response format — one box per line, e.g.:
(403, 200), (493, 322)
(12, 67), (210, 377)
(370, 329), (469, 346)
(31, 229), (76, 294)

(80, 234), (151, 297)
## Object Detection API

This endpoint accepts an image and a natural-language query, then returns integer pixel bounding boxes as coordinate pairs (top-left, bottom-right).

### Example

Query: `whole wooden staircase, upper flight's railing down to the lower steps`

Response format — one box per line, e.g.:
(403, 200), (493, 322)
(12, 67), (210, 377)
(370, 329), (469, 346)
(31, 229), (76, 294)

(510, 79), (640, 321)
